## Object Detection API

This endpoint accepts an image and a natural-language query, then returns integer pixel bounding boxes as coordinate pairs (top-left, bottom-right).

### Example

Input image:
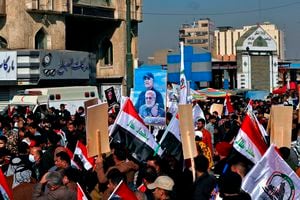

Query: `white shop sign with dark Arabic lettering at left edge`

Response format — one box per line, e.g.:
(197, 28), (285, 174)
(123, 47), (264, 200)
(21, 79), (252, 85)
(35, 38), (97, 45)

(0, 51), (17, 81)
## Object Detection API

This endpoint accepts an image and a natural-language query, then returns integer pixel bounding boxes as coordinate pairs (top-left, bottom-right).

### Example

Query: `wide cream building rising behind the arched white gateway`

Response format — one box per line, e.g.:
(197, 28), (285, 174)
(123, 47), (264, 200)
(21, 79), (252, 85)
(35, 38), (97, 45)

(215, 22), (285, 61)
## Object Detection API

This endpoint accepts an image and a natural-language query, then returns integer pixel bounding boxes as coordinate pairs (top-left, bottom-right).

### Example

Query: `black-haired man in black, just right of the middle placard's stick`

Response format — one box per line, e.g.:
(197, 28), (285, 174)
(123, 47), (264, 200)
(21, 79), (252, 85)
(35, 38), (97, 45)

(192, 155), (216, 200)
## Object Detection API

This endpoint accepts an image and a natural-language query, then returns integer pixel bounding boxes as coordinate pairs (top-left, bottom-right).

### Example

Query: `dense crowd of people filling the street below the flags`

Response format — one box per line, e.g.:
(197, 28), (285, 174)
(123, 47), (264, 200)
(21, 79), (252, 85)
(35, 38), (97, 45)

(0, 89), (300, 200)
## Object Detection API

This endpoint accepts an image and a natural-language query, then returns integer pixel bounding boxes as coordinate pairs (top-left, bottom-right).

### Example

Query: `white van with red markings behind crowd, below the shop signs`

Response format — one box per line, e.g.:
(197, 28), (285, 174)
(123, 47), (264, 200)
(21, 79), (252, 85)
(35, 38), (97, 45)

(10, 86), (99, 114)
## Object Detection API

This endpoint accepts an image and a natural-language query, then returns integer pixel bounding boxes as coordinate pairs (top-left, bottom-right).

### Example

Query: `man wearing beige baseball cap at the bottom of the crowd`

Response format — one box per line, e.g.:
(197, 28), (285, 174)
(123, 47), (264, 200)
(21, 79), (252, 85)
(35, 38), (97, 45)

(147, 176), (174, 200)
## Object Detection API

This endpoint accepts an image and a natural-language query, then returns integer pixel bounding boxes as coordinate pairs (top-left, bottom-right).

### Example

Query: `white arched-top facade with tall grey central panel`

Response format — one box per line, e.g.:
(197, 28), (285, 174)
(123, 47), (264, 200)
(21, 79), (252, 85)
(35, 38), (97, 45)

(236, 26), (278, 92)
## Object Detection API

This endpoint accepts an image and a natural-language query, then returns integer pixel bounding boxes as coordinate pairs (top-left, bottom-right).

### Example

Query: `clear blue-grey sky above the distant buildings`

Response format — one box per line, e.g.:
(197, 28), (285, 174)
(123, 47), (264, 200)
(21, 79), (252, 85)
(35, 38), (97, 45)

(139, 0), (300, 62)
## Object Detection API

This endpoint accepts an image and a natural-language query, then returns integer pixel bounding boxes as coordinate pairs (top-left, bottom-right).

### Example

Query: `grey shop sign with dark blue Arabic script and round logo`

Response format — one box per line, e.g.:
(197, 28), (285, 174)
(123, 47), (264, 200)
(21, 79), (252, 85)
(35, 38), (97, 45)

(40, 51), (90, 79)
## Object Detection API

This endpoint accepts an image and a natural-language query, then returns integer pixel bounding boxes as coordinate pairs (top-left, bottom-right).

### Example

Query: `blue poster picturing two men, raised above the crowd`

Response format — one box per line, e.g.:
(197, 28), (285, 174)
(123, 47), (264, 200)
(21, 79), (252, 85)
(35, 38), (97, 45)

(133, 66), (167, 125)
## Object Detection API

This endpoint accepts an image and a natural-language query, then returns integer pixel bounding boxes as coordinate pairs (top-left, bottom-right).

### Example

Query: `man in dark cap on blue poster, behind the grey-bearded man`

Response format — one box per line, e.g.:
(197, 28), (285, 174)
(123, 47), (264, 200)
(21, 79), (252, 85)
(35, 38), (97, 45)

(134, 72), (164, 111)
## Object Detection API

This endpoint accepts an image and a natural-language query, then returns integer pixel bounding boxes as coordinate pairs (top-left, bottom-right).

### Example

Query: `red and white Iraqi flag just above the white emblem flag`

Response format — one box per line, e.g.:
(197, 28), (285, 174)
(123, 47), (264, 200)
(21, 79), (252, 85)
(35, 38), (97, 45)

(233, 114), (268, 164)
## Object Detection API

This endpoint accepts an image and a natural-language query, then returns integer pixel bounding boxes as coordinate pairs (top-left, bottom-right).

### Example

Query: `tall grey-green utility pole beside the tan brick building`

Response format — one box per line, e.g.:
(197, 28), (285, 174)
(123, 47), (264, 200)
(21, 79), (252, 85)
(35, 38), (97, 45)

(126, 0), (133, 97)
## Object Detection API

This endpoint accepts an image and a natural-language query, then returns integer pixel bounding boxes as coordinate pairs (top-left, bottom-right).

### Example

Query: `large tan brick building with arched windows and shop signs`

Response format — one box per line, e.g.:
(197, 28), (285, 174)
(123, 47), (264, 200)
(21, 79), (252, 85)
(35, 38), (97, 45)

(0, 0), (142, 108)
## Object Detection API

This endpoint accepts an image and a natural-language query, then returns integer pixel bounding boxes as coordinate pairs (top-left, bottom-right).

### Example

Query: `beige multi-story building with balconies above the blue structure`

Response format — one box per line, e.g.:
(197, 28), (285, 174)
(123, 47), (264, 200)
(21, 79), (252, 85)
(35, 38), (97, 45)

(179, 18), (215, 52)
